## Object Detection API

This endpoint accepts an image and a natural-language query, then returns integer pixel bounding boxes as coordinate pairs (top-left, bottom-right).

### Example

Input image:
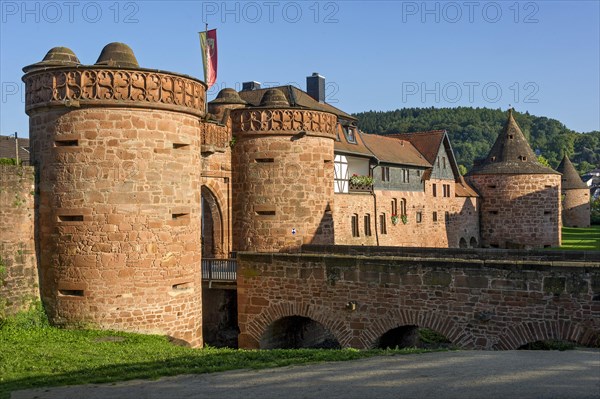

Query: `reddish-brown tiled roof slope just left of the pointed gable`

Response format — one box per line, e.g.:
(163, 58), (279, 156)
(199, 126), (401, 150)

(360, 133), (431, 168)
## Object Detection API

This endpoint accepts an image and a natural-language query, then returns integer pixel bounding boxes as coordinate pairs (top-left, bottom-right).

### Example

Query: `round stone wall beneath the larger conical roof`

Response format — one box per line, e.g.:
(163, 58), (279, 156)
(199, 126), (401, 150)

(468, 174), (561, 248)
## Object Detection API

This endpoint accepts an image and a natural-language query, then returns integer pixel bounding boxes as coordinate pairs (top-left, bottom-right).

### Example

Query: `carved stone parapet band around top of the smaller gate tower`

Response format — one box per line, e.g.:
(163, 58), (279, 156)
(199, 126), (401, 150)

(232, 108), (337, 138)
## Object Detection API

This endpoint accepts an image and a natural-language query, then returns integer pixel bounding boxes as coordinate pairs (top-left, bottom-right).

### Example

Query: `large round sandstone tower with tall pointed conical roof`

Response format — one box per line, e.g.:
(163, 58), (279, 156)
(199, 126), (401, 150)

(467, 109), (561, 248)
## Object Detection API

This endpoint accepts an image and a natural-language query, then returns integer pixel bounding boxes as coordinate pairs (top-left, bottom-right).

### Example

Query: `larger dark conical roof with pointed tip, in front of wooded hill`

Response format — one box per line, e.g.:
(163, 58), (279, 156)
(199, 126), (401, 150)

(469, 109), (558, 175)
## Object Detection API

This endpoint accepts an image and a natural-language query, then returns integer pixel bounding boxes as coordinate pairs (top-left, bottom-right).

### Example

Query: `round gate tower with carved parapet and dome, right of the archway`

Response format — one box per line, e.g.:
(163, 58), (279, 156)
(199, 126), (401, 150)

(231, 89), (337, 252)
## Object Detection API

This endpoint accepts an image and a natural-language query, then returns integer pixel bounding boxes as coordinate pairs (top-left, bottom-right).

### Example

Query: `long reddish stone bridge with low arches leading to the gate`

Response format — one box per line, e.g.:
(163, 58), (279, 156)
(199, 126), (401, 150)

(237, 247), (600, 350)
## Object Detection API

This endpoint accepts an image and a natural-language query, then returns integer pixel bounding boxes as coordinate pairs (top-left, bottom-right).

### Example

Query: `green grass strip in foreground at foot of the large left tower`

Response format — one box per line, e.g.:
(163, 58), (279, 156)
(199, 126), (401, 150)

(0, 305), (438, 398)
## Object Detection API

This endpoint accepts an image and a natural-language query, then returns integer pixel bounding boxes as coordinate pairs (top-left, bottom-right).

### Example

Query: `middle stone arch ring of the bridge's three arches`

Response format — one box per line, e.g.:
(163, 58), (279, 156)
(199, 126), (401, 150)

(364, 309), (475, 349)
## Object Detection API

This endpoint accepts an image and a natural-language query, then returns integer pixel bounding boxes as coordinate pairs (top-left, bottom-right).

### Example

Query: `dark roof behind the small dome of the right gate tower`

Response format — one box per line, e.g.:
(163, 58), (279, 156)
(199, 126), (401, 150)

(238, 85), (357, 121)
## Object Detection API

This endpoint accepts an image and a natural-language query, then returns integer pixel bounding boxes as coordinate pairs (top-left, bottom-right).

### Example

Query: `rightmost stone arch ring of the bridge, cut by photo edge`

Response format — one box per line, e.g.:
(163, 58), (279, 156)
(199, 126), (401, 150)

(492, 320), (600, 350)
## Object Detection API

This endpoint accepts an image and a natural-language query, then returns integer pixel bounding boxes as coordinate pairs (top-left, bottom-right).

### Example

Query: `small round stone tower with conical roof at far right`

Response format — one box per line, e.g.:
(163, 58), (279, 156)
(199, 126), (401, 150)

(556, 155), (590, 227)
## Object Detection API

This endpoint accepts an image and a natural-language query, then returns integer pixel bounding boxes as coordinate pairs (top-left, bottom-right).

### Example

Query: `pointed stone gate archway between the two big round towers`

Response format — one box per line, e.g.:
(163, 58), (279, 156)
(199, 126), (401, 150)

(201, 186), (227, 258)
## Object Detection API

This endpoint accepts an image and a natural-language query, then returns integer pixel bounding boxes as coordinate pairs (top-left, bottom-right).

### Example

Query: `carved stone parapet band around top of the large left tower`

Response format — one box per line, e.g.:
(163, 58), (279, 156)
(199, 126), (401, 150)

(23, 66), (206, 117)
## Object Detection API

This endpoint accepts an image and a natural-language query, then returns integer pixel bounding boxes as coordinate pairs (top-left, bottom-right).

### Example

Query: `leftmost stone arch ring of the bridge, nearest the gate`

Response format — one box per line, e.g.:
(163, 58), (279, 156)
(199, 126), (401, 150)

(239, 302), (352, 349)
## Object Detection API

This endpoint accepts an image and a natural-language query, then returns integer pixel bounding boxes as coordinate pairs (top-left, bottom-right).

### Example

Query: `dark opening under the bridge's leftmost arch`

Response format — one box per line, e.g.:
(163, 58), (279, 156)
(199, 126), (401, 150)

(260, 316), (341, 349)
